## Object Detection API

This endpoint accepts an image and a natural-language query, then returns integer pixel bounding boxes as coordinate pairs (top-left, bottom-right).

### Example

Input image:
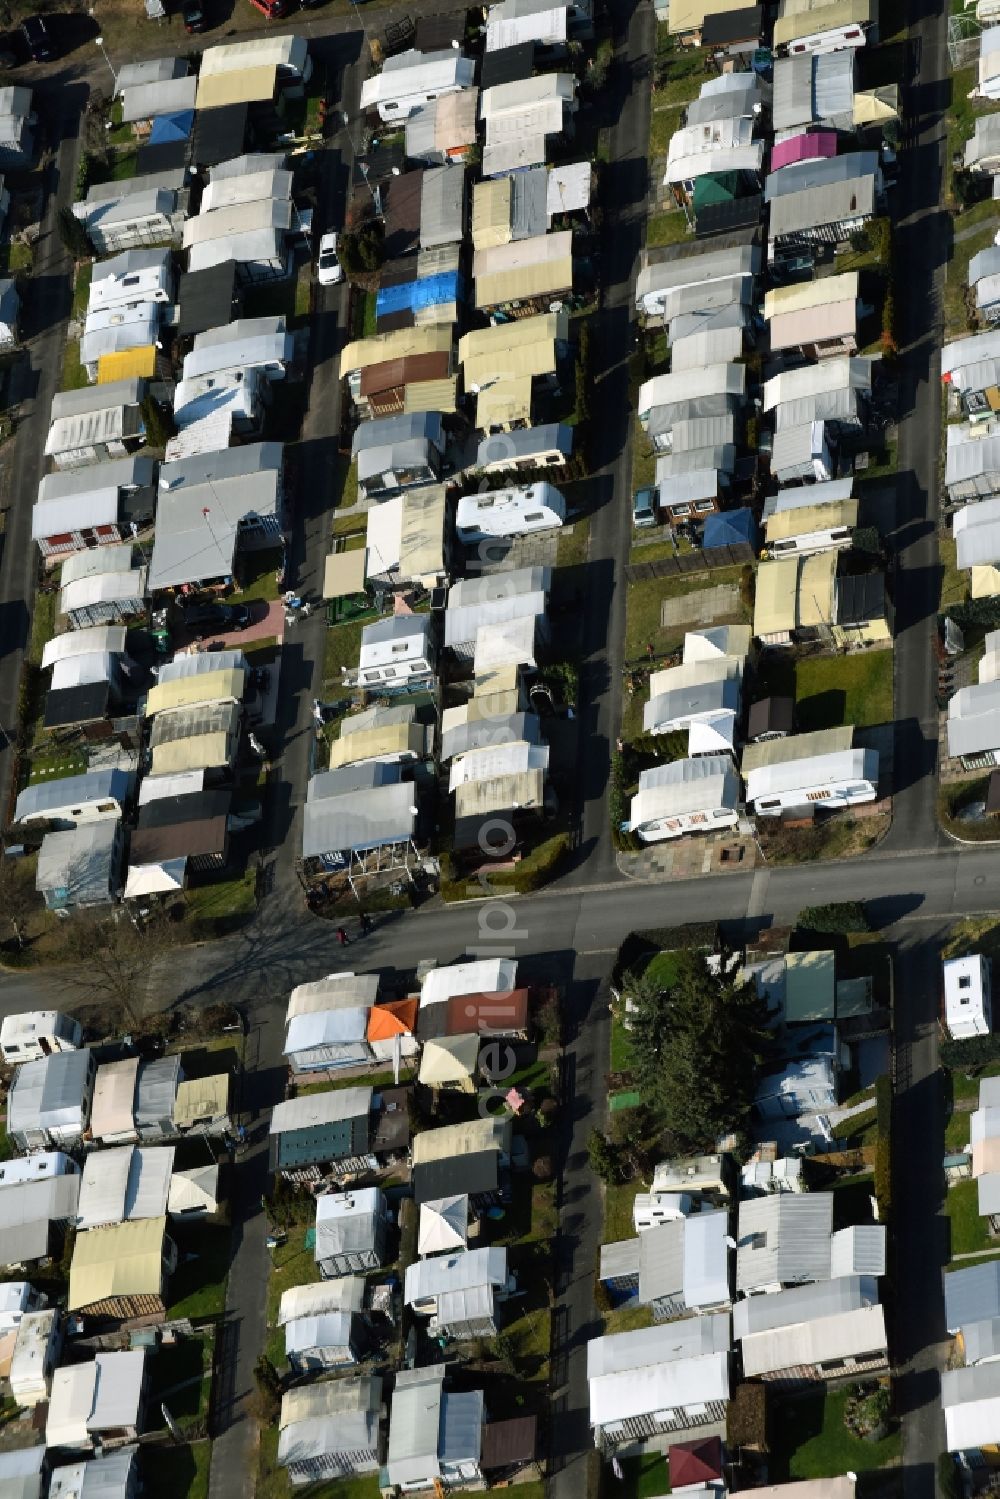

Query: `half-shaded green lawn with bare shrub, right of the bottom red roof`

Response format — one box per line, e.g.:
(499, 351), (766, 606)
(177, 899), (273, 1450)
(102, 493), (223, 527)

(769, 1390), (903, 1483)
